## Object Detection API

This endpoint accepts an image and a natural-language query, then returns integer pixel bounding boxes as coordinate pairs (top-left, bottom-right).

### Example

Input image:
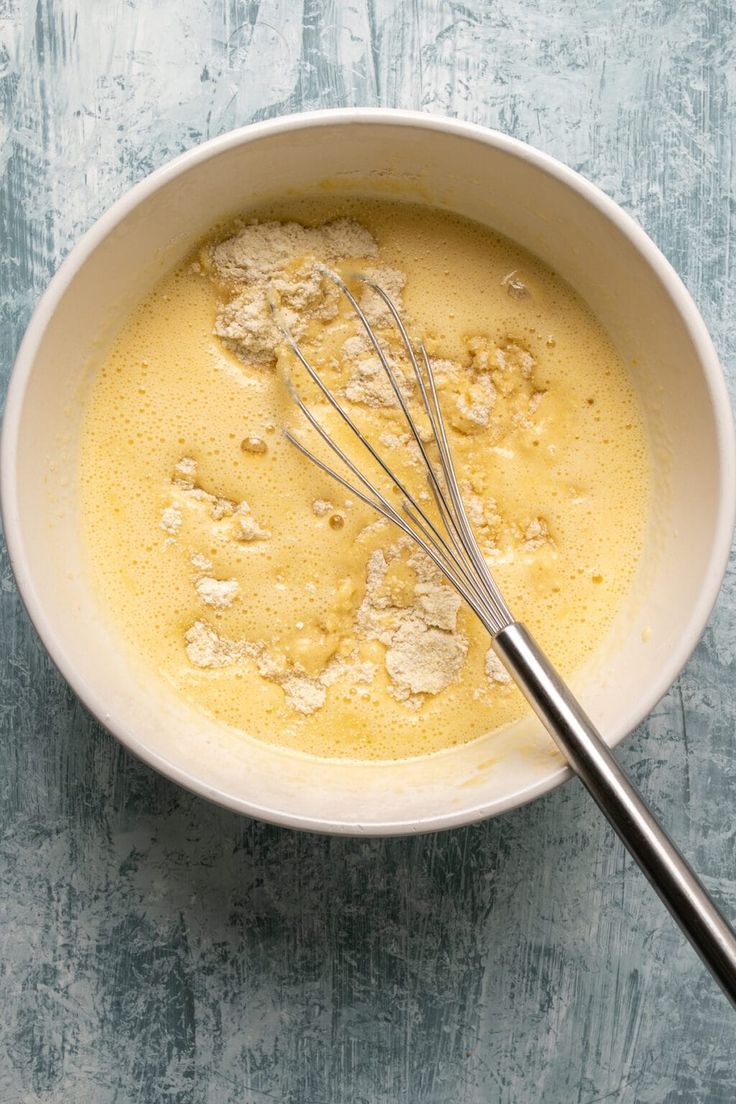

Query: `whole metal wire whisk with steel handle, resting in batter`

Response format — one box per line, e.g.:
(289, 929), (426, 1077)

(276, 268), (736, 1005)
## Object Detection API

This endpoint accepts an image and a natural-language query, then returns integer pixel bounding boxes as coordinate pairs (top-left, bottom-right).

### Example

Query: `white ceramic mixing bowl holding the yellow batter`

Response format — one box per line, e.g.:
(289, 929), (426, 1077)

(2, 110), (736, 835)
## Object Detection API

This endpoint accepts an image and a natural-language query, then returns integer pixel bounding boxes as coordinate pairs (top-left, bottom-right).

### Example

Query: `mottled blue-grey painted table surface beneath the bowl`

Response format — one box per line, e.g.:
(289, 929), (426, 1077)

(0, 0), (736, 1104)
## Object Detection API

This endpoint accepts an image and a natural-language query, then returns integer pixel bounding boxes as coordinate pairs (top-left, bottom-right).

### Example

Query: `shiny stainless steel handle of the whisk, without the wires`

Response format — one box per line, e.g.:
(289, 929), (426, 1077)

(493, 622), (736, 1005)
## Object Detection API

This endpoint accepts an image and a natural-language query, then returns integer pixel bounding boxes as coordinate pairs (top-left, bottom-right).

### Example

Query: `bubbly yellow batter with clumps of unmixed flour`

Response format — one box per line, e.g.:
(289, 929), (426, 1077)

(79, 197), (649, 758)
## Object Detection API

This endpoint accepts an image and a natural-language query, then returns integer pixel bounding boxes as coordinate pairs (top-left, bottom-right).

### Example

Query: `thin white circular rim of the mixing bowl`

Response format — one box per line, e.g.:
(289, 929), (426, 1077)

(0, 108), (736, 836)
